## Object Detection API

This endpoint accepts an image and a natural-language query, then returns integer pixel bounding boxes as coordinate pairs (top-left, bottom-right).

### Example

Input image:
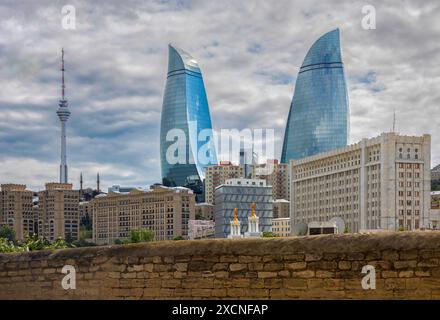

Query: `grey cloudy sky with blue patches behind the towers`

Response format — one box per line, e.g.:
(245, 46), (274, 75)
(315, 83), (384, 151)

(0, 0), (440, 190)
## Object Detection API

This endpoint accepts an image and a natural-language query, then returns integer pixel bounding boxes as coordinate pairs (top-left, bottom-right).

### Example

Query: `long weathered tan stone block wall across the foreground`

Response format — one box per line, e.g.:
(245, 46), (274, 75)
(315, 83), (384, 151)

(0, 232), (440, 299)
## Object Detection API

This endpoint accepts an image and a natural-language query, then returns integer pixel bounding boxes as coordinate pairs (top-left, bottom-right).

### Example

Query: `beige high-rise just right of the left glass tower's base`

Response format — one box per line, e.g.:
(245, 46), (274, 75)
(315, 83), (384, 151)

(205, 161), (244, 204)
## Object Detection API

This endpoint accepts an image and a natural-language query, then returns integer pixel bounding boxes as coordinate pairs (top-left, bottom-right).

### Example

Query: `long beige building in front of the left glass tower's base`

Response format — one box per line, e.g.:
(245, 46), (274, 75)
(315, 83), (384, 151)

(90, 185), (195, 244)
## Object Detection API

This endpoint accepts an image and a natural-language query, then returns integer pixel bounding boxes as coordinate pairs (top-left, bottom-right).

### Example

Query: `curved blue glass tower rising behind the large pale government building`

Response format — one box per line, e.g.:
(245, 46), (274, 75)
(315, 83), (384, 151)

(281, 29), (349, 163)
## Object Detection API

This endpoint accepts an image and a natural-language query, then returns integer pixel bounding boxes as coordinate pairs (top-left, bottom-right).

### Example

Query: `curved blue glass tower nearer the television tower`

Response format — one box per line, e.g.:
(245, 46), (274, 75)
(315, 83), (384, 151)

(160, 45), (217, 200)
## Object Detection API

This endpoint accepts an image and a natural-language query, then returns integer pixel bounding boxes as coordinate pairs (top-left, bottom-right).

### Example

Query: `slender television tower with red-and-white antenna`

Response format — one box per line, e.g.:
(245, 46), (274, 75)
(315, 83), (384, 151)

(57, 49), (70, 183)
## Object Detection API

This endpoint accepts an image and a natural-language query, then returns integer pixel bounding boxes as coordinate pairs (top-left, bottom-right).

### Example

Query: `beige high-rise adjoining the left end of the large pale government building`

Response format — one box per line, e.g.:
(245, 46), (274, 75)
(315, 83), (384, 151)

(252, 160), (290, 200)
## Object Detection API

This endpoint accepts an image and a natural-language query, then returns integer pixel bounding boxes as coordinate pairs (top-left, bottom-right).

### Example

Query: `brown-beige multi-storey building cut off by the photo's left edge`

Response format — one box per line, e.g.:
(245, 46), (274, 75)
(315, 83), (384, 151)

(0, 184), (37, 240)
